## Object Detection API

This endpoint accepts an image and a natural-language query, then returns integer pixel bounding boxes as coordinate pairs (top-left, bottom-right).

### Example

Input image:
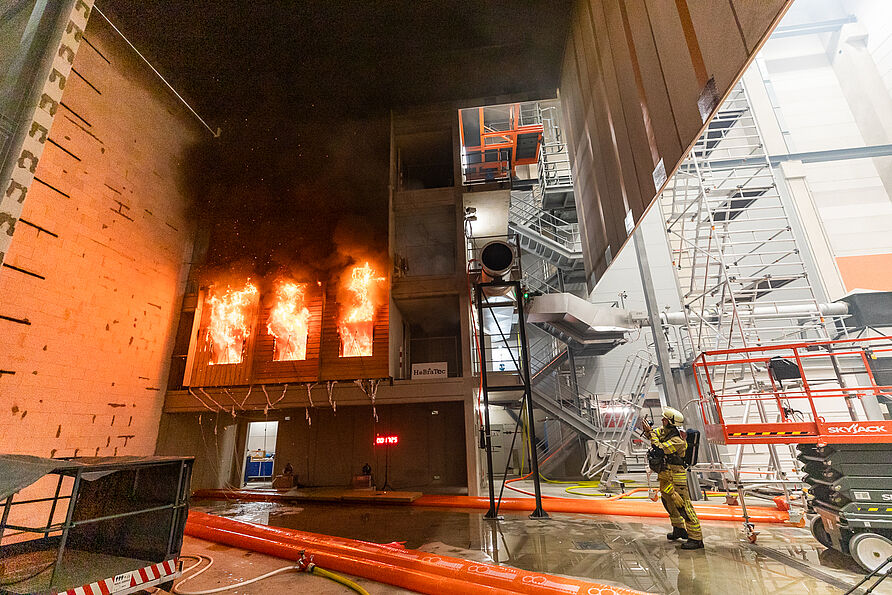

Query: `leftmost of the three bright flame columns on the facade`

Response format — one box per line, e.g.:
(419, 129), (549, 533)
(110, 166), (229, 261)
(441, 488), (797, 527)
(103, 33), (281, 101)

(206, 281), (257, 364)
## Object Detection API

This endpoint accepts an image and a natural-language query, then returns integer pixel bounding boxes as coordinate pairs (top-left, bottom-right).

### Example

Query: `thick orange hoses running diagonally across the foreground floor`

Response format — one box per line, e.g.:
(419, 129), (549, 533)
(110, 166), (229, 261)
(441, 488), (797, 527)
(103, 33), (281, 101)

(186, 511), (641, 595)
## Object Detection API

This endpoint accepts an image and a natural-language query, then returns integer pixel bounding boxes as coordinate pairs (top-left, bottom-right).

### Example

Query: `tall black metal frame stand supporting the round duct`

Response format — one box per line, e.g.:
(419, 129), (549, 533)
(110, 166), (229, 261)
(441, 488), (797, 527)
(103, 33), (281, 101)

(474, 281), (549, 519)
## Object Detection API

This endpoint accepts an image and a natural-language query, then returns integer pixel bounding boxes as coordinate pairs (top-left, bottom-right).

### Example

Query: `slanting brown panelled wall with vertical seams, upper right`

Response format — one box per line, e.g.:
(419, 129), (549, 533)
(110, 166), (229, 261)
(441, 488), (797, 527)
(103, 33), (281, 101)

(560, 0), (789, 287)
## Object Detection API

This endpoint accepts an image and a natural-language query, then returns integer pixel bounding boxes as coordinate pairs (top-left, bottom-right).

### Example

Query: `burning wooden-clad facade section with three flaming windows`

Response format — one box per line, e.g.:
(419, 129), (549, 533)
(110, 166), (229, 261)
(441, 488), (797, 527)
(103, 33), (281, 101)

(183, 261), (388, 387)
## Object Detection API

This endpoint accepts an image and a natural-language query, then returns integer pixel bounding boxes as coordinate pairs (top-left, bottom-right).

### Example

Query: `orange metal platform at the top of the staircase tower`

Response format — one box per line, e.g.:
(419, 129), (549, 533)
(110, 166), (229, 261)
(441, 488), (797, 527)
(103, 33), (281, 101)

(458, 102), (543, 184)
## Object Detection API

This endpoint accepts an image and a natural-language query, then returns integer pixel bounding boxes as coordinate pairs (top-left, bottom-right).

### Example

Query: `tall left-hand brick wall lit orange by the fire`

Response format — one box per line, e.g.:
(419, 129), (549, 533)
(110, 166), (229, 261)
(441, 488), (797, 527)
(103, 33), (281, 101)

(0, 15), (200, 457)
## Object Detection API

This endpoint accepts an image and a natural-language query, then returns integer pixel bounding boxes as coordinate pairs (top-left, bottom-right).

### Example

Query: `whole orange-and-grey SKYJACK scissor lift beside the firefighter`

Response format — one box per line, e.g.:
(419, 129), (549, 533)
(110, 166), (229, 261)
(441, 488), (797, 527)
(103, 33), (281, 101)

(693, 337), (892, 572)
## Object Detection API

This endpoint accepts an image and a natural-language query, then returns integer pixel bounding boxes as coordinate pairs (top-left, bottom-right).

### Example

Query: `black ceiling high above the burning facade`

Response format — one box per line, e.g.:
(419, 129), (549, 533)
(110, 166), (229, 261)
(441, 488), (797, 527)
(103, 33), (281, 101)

(98, 0), (572, 125)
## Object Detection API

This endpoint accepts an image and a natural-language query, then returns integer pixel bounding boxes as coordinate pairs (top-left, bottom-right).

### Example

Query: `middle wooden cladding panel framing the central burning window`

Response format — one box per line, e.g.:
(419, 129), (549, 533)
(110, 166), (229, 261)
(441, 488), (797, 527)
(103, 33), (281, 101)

(253, 285), (323, 384)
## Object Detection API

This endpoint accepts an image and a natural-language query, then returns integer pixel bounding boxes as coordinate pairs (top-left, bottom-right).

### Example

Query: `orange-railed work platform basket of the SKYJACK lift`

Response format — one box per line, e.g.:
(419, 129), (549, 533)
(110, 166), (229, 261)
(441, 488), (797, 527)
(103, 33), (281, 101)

(693, 337), (892, 445)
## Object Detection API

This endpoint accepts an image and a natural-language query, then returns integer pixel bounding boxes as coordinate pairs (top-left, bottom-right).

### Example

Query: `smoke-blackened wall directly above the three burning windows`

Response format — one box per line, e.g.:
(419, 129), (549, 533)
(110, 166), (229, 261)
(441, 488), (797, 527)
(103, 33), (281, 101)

(186, 118), (389, 281)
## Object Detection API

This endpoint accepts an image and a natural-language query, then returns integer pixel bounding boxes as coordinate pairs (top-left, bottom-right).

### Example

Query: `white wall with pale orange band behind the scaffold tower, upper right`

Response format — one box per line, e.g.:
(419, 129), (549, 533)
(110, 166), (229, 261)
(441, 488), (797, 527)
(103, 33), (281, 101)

(748, 0), (892, 298)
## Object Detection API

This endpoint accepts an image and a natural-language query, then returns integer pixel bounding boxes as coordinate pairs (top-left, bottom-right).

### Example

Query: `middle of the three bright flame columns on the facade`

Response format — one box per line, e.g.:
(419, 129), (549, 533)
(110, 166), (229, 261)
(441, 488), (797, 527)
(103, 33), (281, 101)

(266, 282), (310, 362)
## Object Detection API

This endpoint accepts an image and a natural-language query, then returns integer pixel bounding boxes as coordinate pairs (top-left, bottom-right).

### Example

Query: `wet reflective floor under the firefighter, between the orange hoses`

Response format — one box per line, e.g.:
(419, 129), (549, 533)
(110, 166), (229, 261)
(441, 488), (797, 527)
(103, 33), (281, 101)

(193, 501), (892, 595)
